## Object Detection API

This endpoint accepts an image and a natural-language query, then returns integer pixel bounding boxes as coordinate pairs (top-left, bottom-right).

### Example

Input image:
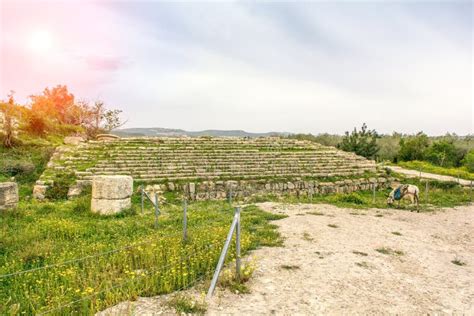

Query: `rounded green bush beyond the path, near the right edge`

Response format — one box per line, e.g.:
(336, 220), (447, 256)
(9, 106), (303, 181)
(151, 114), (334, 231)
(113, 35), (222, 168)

(425, 140), (465, 167)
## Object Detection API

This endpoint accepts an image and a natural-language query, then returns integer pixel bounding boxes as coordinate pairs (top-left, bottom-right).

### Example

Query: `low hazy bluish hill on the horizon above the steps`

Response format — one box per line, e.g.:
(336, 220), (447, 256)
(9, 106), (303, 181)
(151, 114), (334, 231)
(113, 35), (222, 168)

(112, 127), (290, 137)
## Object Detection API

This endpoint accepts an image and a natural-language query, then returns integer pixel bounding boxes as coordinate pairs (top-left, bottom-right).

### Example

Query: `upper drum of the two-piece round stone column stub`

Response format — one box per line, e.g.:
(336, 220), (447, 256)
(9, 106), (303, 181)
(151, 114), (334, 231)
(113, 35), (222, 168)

(92, 175), (133, 200)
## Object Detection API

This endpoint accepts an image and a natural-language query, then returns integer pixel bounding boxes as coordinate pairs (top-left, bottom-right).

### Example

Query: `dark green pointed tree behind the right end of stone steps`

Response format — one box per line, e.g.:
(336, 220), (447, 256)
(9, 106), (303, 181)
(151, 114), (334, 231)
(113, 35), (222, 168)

(337, 123), (379, 159)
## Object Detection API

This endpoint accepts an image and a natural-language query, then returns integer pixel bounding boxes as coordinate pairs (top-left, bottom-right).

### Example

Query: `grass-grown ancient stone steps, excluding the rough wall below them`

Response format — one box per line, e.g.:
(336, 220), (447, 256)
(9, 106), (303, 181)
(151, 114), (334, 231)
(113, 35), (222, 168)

(37, 137), (375, 182)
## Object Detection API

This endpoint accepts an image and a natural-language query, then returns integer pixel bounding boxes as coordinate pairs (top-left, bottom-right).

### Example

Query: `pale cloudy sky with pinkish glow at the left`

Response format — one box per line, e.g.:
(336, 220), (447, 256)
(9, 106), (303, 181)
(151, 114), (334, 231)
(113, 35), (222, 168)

(0, 1), (474, 134)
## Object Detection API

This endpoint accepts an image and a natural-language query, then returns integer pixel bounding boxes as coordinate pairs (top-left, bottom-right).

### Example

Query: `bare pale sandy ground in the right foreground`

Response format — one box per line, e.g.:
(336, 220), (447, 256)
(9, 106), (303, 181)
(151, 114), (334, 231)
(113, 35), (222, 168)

(99, 203), (474, 315)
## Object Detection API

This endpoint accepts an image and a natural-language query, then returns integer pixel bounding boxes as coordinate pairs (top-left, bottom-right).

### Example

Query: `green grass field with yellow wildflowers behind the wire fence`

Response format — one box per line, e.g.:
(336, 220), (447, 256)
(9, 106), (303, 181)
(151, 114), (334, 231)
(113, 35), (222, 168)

(0, 196), (282, 315)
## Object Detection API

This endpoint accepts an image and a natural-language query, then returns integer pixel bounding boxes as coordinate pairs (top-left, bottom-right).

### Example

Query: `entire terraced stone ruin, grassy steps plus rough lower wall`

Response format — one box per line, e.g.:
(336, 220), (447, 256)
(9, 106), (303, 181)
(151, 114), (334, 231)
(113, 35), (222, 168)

(35, 137), (386, 199)
